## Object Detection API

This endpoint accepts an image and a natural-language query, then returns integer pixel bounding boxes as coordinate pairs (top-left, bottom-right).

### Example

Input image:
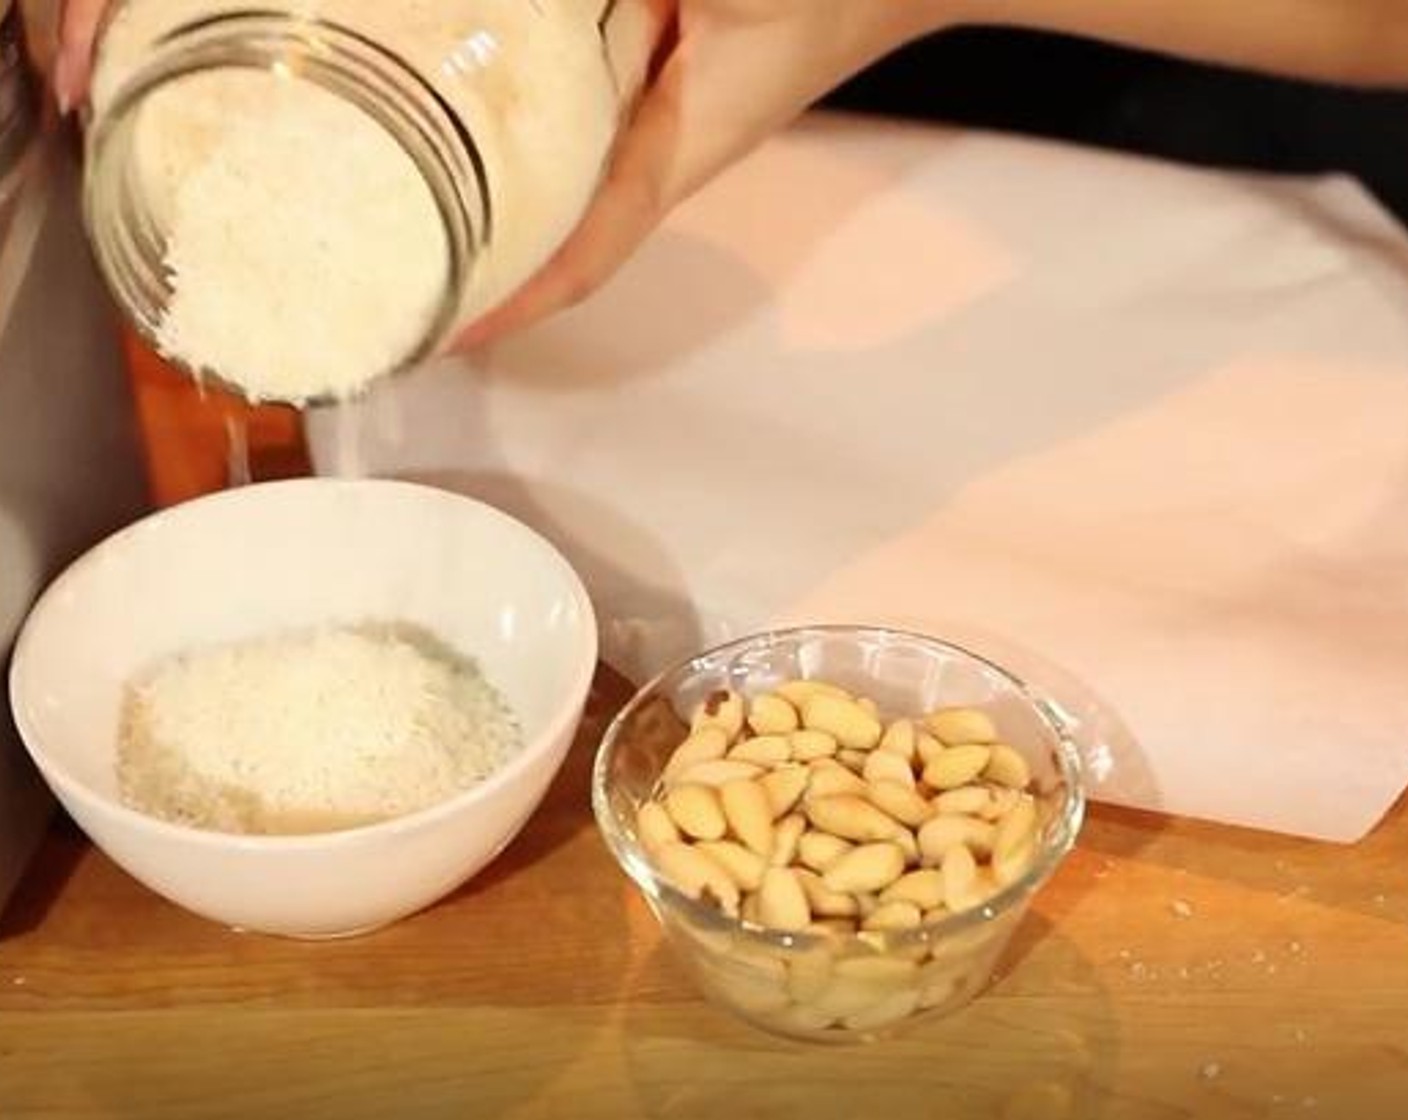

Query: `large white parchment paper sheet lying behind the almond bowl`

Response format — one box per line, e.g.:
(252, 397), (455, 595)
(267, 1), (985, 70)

(310, 117), (1408, 841)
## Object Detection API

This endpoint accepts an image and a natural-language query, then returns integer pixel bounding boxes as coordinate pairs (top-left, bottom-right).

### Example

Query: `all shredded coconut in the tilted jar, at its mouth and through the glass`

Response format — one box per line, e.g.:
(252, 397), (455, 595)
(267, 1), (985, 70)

(93, 0), (655, 403)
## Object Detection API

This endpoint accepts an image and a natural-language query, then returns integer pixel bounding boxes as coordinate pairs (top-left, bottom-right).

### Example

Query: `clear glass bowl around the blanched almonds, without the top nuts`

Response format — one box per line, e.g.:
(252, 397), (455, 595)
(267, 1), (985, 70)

(593, 627), (1084, 1043)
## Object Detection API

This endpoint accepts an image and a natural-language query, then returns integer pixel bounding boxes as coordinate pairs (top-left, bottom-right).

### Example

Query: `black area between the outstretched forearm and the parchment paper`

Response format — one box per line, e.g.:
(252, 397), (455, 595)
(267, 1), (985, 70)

(826, 28), (1408, 224)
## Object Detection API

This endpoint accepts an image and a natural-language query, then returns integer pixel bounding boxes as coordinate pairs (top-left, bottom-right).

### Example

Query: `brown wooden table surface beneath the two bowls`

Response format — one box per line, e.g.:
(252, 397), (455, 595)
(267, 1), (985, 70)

(0, 339), (1408, 1120)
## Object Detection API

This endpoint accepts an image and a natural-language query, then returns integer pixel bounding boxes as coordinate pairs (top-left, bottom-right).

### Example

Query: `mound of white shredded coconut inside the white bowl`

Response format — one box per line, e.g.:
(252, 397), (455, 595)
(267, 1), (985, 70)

(118, 624), (521, 833)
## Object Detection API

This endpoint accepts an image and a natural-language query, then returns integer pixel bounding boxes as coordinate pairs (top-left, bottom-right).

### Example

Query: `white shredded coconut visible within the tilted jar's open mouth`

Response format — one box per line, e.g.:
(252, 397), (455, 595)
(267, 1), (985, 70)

(144, 72), (449, 402)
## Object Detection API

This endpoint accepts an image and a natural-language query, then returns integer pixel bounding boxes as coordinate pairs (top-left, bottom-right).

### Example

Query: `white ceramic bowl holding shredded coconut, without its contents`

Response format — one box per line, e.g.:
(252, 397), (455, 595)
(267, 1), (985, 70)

(2, 479), (597, 937)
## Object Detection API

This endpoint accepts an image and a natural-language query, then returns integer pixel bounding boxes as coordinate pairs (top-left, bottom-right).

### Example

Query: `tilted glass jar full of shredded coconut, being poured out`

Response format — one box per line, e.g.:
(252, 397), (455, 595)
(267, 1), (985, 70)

(84, 0), (662, 404)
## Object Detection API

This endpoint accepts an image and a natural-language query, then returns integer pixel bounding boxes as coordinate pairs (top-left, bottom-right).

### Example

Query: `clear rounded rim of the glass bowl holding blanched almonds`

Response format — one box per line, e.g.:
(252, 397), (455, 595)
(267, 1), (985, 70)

(591, 623), (1087, 954)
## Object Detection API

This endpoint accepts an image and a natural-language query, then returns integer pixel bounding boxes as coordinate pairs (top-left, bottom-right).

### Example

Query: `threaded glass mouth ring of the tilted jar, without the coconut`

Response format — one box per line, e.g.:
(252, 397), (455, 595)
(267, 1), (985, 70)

(83, 11), (493, 407)
